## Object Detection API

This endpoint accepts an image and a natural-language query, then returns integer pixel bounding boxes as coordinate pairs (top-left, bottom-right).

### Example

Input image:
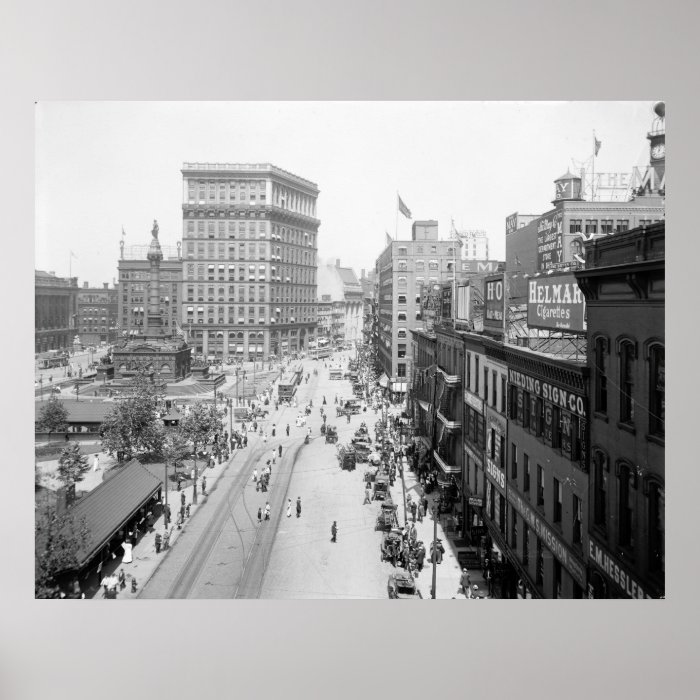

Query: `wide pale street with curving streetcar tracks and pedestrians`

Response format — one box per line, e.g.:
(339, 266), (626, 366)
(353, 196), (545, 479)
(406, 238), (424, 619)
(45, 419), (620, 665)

(140, 355), (438, 599)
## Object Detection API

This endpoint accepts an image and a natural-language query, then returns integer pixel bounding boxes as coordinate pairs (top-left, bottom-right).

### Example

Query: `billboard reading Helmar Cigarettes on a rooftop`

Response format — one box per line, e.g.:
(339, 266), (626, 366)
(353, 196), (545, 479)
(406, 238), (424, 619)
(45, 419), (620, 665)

(527, 273), (586, 333)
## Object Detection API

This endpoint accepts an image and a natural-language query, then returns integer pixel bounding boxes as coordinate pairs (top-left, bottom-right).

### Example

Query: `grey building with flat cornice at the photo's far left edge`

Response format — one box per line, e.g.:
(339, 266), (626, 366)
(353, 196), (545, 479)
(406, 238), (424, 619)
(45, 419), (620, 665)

(34, 270), (78, 353)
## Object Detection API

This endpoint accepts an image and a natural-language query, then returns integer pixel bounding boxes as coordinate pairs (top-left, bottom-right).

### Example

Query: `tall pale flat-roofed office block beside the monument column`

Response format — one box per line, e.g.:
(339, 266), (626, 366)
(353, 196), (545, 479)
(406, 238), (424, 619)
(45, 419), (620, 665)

(182, 163), (320, 360)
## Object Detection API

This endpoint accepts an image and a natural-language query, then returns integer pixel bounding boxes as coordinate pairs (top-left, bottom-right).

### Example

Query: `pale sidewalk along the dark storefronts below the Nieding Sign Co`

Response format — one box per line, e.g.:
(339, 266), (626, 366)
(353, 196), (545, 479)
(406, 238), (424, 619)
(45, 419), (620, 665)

(390, 462), (488, 600)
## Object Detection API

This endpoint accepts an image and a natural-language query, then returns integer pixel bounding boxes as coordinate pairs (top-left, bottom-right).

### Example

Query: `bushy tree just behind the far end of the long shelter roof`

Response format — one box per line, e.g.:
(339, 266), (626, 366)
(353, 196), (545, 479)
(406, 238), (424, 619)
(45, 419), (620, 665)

(102, 373), (165, 459)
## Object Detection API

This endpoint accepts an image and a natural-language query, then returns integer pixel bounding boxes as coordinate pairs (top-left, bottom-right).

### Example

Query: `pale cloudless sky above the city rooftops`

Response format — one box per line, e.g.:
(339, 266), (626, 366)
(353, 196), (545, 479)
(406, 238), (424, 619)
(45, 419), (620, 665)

(35, 101), (654, 286)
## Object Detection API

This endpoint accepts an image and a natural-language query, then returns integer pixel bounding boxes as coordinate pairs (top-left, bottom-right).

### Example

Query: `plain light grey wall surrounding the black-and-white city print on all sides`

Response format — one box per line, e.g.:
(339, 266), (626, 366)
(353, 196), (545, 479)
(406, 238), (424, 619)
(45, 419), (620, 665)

(0, 0), (699, 700)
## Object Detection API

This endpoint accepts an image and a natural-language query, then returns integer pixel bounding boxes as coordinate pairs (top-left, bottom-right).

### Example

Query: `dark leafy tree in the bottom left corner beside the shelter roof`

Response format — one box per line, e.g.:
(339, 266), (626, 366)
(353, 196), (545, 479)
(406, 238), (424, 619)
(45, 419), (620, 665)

(34, 510), (91, 598)
